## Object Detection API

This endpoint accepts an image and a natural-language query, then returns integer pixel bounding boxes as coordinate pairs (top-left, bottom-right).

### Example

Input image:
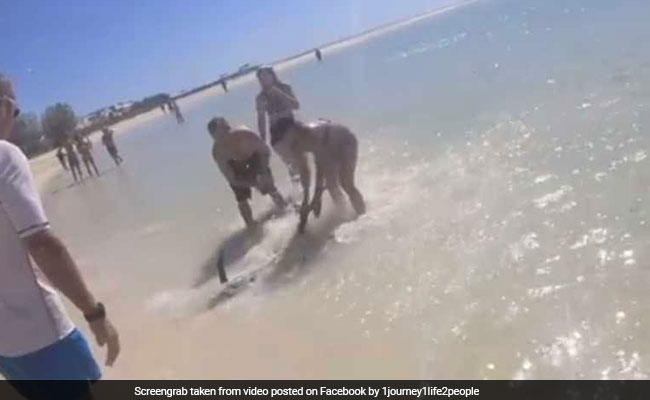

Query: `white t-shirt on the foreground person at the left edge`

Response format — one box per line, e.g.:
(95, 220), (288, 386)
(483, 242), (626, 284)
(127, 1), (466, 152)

(0, 140), (74, 357)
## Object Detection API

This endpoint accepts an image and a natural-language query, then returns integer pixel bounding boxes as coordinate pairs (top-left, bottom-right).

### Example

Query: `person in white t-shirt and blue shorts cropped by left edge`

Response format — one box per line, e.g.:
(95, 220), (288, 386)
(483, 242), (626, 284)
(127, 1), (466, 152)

(0, 75), (120, 399)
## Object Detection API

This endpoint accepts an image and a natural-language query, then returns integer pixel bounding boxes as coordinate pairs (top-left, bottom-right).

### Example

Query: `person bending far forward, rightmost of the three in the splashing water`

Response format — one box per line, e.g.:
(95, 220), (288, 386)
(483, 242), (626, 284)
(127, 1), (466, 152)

(288, 121), (366, 233)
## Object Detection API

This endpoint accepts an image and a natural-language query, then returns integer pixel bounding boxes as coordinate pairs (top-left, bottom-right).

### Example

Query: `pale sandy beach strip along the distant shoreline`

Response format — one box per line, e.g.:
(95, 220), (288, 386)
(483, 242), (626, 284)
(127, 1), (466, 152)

(29, 0), (479, 192)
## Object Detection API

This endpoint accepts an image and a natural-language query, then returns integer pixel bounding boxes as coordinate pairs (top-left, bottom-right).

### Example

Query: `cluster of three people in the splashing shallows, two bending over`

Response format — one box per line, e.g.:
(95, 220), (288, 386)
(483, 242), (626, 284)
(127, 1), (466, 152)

(207, 67), (366, 233)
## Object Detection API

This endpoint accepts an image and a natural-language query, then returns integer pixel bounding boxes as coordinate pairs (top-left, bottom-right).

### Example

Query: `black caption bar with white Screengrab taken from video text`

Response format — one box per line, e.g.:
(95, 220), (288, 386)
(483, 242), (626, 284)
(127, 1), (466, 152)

(0, 381), (650, 400)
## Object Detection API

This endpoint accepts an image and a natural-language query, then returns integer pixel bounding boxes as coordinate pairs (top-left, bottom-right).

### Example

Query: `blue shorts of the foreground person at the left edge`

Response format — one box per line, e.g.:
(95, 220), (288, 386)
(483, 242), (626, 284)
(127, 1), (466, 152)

(0, 329), (102, 381)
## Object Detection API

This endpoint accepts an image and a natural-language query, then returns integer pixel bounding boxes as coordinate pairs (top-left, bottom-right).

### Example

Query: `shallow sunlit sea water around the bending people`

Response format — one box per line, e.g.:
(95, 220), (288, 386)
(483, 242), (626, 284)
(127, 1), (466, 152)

(39, 0), (650, 379)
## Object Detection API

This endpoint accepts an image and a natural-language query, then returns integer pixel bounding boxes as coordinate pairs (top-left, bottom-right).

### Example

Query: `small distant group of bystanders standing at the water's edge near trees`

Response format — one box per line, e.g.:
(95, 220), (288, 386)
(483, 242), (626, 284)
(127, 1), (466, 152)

(56, 128), (124, 183)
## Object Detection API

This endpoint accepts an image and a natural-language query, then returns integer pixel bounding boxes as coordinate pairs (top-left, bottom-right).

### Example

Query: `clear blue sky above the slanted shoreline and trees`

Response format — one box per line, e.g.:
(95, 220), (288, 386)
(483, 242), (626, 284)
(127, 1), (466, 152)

(0, 0), (453, 115)
